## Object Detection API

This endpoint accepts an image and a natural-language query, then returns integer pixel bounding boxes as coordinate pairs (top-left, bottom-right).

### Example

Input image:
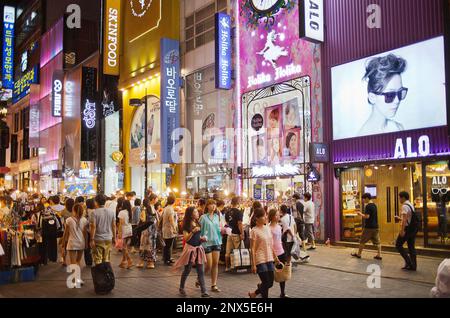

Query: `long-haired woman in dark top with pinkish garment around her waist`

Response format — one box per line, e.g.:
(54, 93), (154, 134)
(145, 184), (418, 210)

(174, 206), (209, 298)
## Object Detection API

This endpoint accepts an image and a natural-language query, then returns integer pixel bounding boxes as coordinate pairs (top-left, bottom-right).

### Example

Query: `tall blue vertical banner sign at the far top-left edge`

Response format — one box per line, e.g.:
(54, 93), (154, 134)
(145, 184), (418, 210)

(2, 6), (16, 89)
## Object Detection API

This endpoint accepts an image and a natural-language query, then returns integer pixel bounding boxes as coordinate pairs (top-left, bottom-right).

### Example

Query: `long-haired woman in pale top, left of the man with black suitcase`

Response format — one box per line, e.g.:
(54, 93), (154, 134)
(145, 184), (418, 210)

(63, 204), (89, 284)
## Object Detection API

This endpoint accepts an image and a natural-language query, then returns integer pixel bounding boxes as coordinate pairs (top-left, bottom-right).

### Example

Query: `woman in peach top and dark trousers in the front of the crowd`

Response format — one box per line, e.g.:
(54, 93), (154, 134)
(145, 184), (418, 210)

(248, 209), (280, 298)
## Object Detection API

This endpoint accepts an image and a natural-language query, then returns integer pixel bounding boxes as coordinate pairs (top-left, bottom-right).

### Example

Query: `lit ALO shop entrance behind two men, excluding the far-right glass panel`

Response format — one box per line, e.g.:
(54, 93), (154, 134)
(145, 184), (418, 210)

(341, 163), (424, 246)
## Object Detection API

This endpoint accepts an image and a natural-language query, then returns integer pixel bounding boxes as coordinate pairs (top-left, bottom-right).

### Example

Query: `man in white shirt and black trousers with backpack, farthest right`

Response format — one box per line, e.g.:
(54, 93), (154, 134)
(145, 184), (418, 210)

(395, 192), (418, 271)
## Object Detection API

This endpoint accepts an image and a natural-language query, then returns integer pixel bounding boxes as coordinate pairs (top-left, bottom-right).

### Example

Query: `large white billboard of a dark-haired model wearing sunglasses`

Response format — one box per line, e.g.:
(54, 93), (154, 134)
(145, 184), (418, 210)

(332, 37), (447, 140)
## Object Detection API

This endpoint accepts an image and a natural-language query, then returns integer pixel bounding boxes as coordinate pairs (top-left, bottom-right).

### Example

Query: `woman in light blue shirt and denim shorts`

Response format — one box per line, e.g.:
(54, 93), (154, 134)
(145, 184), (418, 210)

(200, 199), (222, 293)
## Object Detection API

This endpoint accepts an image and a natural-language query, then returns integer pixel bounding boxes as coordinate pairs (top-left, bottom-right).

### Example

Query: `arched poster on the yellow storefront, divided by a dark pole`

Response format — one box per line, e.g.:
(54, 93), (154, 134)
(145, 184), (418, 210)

(129, 96), (161, 166)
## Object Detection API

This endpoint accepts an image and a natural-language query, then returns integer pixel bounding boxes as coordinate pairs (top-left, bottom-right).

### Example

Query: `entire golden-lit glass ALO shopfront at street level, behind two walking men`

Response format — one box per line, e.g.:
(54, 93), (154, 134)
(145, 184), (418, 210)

(341, 161), (450, 249)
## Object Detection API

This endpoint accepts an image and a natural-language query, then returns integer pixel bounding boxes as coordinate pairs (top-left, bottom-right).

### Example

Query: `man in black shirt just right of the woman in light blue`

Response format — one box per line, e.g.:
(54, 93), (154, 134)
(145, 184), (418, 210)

(225, 197), (244, 271)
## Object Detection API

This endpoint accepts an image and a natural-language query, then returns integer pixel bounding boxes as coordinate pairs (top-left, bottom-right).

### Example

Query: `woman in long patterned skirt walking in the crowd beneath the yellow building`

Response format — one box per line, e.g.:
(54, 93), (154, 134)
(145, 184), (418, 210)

(137, 193), (159, 269)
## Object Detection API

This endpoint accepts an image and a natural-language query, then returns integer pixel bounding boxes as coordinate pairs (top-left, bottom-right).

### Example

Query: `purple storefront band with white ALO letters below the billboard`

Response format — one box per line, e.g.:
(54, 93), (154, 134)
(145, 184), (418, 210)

(333, 126), (450, 164)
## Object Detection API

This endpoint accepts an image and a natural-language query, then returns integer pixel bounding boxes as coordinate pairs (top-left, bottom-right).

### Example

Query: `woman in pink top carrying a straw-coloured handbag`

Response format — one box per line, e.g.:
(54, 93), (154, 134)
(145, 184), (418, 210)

(269, 209), (292, 298)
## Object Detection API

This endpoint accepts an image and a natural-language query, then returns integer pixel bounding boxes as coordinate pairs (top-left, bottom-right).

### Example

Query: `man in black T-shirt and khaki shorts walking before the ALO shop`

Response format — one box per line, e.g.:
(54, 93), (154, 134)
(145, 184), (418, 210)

(352, 193), (382, 260)
